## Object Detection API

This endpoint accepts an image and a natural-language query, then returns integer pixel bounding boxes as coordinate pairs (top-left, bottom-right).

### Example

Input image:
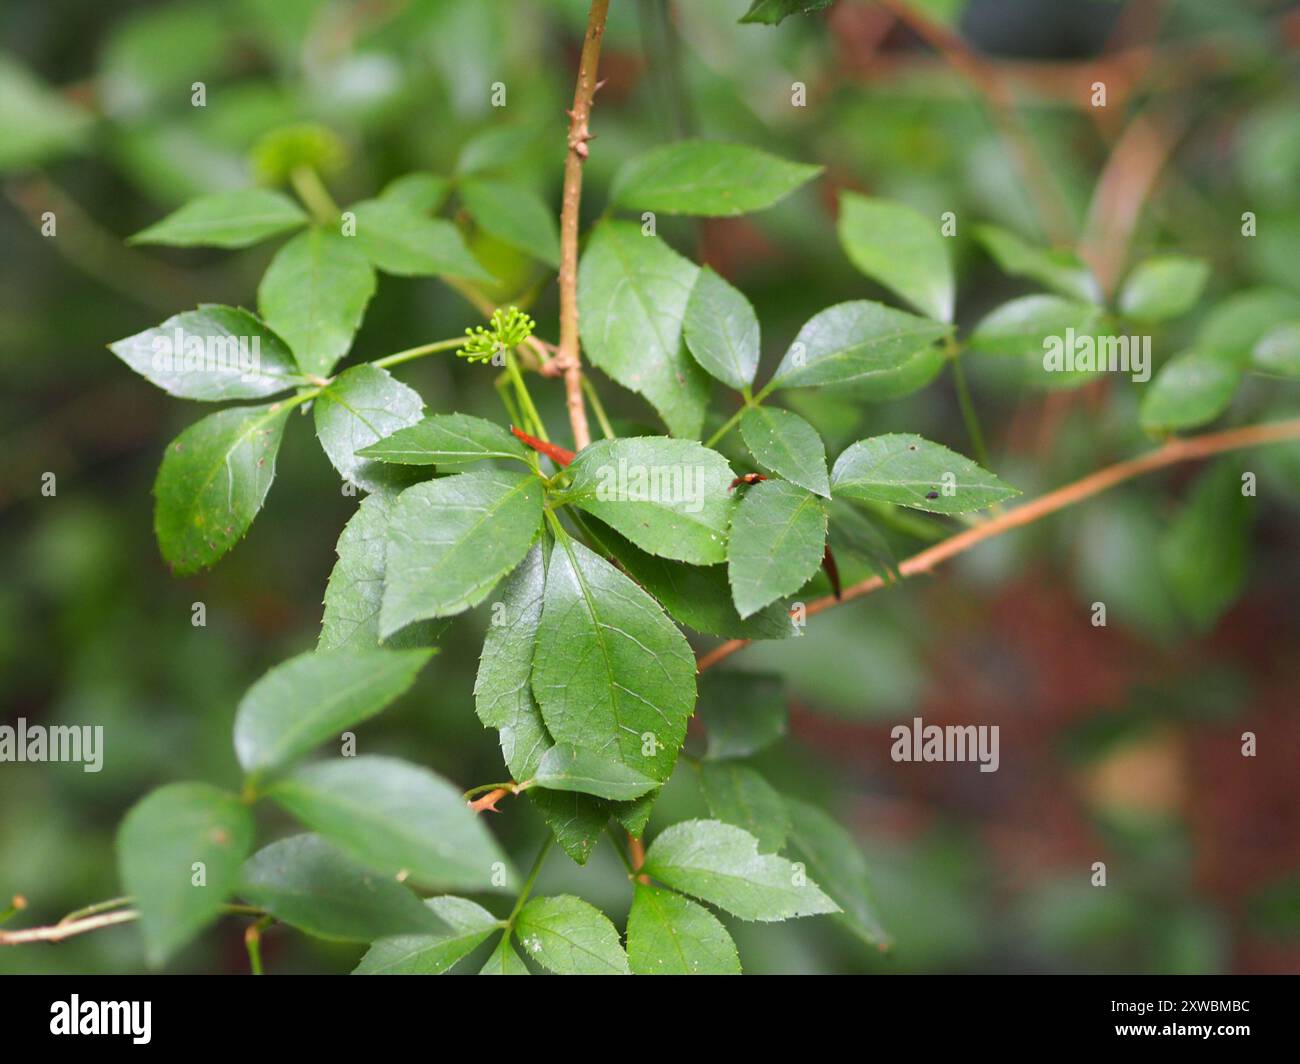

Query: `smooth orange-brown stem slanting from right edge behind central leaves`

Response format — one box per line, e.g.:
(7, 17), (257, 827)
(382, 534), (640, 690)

(696, 418), (1300, 672)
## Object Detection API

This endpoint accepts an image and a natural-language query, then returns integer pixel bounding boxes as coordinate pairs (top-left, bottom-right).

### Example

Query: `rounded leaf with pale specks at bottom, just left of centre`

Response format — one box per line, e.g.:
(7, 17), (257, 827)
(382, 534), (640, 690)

(515, 894), (632, 976)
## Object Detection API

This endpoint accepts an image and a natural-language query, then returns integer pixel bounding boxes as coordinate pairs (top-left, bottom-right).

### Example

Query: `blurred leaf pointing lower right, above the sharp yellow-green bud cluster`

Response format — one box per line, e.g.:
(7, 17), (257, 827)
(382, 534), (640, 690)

(351, 198), (493, 281)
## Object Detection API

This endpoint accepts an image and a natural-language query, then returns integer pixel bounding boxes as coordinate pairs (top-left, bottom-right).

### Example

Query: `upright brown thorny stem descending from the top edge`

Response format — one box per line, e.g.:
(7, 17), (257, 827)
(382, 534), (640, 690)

(558, 0), (610, 450)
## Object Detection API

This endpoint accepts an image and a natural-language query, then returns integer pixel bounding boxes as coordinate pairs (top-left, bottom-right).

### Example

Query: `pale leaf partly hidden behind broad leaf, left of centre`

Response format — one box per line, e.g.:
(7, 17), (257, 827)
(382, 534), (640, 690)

(316, 496), (434, 650)
